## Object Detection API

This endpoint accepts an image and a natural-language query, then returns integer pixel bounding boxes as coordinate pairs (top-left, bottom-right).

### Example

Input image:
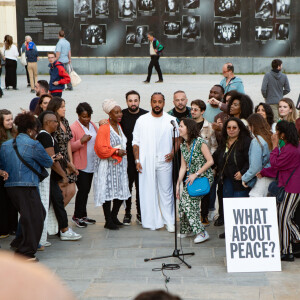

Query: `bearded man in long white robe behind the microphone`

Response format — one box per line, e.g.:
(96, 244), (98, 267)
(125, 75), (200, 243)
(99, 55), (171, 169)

(132, 93), (179, 232)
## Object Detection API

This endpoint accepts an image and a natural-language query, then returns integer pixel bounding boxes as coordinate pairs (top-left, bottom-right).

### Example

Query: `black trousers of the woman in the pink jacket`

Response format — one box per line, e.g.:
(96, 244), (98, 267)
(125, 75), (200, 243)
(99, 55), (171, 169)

(74, 170), (94, 219)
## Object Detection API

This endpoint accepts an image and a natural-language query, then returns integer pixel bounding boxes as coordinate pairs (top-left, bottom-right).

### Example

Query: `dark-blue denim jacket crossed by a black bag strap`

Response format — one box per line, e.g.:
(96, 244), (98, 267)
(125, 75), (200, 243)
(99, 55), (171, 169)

(0, 133), (53, 187)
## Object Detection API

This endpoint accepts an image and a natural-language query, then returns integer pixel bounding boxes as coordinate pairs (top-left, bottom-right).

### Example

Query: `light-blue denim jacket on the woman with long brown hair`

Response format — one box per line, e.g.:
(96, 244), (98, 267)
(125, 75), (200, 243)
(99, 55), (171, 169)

(242, 135), (270, 182)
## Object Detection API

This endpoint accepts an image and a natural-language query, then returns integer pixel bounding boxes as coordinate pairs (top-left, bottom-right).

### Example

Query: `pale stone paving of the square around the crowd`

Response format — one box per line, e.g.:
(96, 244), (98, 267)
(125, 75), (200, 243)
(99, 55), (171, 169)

(0, 75), (300, 300)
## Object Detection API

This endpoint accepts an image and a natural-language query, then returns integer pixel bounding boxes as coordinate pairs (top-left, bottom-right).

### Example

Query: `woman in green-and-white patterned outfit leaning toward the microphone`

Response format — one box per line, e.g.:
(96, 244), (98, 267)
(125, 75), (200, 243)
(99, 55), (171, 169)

(176, 118), (214, 243)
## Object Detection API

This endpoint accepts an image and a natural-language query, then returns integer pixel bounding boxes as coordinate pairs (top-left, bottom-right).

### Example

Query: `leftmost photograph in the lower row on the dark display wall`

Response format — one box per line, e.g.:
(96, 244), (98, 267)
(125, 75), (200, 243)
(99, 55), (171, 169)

(80, 24), (106, 46)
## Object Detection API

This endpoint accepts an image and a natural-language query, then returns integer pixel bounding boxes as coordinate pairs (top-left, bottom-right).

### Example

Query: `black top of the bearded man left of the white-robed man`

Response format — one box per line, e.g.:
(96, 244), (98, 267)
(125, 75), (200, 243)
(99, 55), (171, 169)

(121, 108), (148, 158)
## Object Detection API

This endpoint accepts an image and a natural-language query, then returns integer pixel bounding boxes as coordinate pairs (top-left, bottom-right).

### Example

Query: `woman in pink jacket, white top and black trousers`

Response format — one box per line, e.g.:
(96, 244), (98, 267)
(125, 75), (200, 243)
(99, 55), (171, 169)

(70, 102), (98, 227)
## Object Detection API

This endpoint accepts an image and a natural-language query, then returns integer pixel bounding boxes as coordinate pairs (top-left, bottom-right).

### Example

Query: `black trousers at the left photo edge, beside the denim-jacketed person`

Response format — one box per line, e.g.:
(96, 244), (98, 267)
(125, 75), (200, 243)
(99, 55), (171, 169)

(0, 177), (18, 235)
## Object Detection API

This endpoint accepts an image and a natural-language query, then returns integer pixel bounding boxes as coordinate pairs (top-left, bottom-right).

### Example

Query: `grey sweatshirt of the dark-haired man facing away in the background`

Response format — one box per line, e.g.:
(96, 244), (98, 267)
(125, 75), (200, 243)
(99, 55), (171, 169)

(261, 70), (291, 104)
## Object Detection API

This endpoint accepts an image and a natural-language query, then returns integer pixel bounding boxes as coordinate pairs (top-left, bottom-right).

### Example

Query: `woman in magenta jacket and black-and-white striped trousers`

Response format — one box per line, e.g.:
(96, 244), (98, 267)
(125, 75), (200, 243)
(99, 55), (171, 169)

(257, 120), (300, 261)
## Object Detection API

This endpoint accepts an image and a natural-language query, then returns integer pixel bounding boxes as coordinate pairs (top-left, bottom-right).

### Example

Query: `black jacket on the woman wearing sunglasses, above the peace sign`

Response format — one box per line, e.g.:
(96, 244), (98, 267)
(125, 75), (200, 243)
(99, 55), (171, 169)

(213, 137), (251, 191)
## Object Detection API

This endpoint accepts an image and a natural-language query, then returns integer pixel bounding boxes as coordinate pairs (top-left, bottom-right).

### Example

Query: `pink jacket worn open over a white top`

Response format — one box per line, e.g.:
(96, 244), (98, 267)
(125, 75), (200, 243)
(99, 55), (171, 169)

(70, 121), (98, 170)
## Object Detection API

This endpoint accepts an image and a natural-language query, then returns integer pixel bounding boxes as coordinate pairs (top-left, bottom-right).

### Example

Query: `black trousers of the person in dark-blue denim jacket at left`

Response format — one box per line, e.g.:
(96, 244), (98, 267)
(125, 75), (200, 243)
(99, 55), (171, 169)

(7, 186), (46, 257)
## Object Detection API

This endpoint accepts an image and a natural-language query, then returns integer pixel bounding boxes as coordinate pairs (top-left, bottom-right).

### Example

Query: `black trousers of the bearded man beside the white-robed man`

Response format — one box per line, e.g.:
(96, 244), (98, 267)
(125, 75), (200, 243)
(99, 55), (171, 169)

(125, 157), (141, 215)
